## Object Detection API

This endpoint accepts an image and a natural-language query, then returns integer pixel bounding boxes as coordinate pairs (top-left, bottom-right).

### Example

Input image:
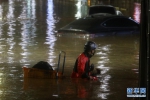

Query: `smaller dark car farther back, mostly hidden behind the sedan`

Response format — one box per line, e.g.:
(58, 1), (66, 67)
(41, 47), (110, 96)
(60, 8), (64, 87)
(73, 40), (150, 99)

(88, 5), (123, 15)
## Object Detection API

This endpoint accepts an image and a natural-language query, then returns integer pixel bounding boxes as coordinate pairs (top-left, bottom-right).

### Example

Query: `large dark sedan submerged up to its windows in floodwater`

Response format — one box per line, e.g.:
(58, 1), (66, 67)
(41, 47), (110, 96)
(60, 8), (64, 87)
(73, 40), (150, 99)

(57, 14), (140, 37)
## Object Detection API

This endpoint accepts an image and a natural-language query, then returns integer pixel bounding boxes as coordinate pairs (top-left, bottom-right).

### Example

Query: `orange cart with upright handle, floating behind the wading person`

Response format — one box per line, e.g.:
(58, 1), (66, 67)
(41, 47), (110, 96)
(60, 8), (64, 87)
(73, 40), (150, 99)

(23, 51), (66, 79)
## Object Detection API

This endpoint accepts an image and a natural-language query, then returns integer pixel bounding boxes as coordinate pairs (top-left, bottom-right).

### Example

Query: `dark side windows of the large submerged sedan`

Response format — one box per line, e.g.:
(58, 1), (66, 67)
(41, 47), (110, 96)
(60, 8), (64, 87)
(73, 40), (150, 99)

(102, 18), (138, 27)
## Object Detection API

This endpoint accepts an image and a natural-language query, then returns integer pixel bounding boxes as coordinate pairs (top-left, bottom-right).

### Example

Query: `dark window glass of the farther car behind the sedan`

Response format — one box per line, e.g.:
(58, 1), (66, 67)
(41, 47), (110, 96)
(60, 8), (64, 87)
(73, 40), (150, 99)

(89, 6), (116, 15)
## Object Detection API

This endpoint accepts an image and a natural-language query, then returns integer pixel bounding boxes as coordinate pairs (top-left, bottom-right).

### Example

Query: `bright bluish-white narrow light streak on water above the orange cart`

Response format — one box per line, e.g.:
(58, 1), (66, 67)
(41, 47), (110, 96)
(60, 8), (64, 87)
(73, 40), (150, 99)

(45, 0), (56, 66)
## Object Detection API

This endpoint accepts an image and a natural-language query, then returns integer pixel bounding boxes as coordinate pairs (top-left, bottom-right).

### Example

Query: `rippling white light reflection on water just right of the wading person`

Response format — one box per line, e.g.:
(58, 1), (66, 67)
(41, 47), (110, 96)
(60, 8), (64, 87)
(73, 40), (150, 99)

(96, 44), (111, 99)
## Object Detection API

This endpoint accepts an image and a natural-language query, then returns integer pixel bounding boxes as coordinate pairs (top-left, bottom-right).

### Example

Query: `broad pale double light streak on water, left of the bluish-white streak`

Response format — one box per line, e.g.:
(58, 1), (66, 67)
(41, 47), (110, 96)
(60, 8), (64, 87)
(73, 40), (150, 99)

(19, 0), (36, 66)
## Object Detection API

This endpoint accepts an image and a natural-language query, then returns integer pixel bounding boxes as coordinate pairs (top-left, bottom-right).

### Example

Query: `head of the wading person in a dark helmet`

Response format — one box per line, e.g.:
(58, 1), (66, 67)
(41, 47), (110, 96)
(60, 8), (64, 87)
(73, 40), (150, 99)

(84, 41), (97, 57)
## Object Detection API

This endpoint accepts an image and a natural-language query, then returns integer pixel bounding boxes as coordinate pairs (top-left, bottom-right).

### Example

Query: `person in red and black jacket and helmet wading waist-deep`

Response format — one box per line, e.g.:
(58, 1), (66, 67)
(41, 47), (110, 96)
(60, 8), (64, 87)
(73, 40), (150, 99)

(71, 41), (97, 80)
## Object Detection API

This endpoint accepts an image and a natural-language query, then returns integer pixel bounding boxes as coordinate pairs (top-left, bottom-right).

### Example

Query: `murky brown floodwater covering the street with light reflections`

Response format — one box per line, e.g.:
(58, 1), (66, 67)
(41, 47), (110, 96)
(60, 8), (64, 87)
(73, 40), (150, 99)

(0, 0), (140, 100)
